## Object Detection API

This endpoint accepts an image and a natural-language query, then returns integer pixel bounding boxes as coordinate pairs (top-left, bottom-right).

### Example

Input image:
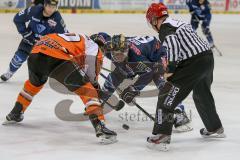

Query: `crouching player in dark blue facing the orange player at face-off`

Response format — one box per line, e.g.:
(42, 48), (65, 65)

(91, 32), (192, 132)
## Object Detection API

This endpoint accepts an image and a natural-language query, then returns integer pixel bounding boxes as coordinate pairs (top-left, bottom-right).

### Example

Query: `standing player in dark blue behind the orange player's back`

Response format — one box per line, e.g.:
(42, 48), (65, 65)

(0, 0), (67, 82)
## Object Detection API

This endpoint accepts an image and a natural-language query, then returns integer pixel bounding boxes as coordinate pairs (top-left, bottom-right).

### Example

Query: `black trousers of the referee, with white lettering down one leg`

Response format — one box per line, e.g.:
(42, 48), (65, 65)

(153, 51), (222, 135)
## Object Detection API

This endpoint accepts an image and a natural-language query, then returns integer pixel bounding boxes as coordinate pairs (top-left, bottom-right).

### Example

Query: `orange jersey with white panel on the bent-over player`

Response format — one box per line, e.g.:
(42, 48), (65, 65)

(32, 33), (103, 82)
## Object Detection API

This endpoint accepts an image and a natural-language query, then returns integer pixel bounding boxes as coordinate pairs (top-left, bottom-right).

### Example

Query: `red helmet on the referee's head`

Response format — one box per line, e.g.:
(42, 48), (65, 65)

(146, 2), (168, 24)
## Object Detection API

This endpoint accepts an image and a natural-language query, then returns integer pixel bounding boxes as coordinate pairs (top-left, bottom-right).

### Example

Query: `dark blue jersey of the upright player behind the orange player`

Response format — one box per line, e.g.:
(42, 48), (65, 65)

(13, 4), (67, 38)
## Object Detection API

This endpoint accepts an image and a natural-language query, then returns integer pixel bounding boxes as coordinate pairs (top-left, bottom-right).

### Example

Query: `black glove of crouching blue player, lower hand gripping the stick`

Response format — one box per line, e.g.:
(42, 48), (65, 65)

(120, 86), (140, 103)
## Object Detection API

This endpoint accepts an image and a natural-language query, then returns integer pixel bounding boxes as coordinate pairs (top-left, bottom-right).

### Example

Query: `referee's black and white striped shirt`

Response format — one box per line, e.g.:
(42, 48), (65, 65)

(159, 17), (210, 64)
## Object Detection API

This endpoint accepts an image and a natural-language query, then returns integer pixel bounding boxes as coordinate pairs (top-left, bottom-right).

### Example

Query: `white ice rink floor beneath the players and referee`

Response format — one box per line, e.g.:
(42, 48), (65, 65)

(0, 14), (240, 160)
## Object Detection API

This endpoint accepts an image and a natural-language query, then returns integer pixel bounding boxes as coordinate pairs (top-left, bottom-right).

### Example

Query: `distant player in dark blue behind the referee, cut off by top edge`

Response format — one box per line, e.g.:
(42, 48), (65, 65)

(186, 0), (214, 48)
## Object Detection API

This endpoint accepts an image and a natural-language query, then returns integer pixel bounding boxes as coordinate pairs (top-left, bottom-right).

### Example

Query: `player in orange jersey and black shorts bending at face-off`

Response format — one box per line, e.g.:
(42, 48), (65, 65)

(4, 33), (117, 144)
